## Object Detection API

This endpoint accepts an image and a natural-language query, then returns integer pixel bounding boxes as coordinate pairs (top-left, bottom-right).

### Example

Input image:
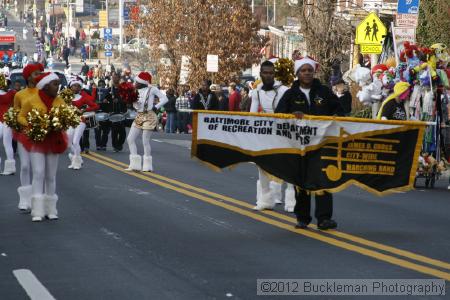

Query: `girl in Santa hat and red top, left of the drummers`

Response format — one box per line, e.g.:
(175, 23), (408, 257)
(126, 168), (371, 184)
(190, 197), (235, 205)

(67, 76), (99, 170)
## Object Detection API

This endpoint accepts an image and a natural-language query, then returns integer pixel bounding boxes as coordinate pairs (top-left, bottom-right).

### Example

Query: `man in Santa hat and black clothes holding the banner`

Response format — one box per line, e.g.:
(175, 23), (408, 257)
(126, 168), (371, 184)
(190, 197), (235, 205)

(275, 57), (341, 230)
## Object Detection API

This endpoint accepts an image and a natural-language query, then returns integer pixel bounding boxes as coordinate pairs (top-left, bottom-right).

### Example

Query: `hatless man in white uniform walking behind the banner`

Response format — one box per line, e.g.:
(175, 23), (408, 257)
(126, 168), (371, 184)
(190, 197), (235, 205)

(250, 61), (295, 212)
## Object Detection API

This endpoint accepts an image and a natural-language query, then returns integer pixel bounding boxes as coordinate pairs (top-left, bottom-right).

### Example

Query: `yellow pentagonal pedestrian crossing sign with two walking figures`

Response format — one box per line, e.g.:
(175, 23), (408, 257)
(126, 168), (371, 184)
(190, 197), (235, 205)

(355, 13), (387, 45)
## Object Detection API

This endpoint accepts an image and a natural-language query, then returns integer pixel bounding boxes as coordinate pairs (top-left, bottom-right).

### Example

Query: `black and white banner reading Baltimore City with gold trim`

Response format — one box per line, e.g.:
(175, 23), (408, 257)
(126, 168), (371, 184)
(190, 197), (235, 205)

(191, 111), (425, 195)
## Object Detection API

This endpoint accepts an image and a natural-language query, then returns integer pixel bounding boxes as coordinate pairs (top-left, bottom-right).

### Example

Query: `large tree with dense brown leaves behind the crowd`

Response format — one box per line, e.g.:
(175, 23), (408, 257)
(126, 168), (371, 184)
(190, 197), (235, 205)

(129, 0), (264, 87)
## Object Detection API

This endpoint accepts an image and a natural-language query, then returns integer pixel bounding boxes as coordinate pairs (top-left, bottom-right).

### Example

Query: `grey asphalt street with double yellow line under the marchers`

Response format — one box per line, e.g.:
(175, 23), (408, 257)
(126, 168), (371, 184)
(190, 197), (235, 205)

(0, 11), (450, 300)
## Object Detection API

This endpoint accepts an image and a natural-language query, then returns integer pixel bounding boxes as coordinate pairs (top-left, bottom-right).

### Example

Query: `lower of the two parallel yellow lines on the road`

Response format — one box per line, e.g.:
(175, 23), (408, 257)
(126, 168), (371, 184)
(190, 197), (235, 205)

(84, 155), (450, 281)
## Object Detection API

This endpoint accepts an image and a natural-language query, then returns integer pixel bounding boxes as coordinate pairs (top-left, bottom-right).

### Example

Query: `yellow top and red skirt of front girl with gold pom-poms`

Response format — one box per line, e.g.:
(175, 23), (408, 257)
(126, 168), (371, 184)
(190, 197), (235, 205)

(17, 90), (68, 153)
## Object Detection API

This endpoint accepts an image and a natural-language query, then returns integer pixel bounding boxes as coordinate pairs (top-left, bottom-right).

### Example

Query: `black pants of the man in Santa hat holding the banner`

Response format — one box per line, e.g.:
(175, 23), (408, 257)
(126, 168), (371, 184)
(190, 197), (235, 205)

(294, 190), (333, 224)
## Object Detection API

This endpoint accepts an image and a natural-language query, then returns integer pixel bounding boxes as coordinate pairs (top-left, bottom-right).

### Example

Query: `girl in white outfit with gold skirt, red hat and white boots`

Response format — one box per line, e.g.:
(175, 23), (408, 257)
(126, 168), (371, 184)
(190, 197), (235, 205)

(126, 72), (169, 172)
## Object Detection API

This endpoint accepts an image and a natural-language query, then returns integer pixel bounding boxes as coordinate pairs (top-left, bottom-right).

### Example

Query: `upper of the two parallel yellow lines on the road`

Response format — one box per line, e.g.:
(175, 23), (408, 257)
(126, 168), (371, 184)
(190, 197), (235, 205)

(87, 152), (450, 270)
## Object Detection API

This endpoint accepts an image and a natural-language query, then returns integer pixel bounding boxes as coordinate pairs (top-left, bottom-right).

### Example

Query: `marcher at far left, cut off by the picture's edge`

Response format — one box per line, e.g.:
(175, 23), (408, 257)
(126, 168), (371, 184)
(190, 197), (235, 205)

(0, 75), (16, 175)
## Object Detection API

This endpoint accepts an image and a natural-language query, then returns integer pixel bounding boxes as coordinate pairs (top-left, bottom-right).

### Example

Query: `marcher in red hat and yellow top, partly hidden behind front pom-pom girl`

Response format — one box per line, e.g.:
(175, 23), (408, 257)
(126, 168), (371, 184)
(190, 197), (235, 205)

(13, 63), (44, 211)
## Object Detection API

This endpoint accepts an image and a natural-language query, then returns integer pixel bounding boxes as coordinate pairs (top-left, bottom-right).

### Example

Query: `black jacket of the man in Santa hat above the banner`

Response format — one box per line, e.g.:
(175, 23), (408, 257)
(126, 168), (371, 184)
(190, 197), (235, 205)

(275, 79), (343, 116)
